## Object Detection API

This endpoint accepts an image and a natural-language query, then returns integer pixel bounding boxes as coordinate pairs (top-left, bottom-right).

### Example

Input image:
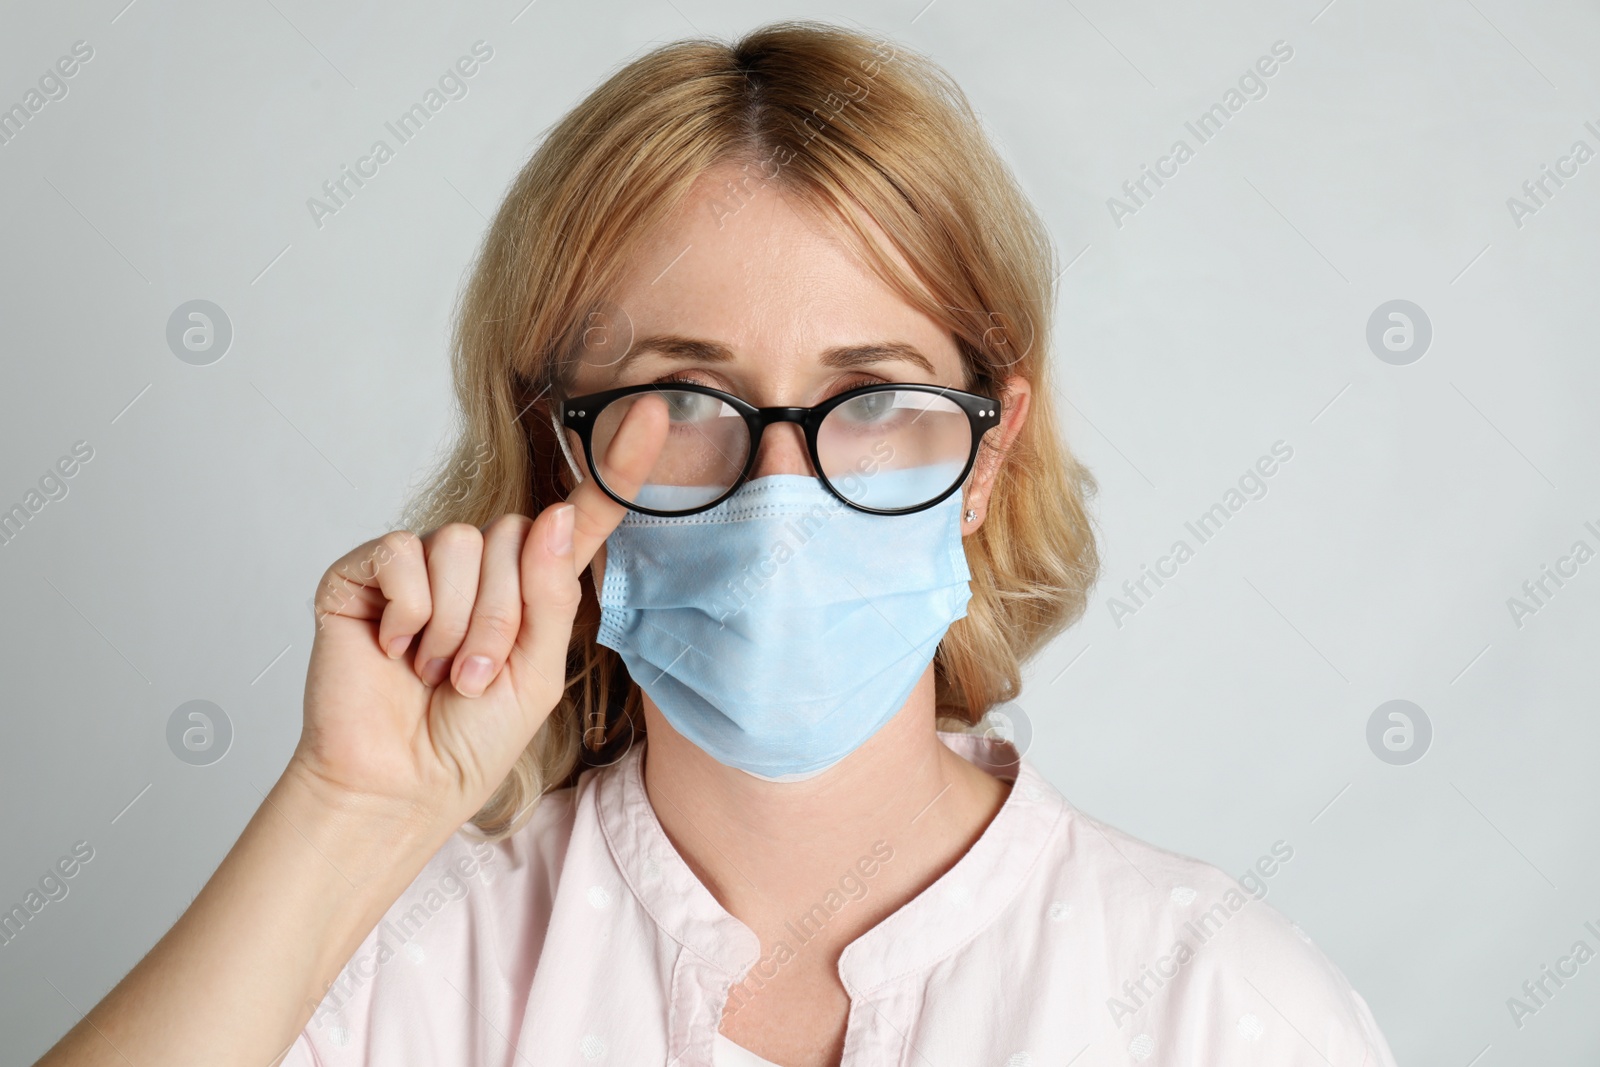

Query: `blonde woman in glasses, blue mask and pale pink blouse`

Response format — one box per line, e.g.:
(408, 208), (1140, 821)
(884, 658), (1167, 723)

(42, 16), (1392, 1067)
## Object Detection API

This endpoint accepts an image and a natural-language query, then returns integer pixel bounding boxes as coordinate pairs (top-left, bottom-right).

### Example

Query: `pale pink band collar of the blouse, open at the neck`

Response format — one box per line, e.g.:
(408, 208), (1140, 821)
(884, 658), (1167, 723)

(597, 731), (1067, 997)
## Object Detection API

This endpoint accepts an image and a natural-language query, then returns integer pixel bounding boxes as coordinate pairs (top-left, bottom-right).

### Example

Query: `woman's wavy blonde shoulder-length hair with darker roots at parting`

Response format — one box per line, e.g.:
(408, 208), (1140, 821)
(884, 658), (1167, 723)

(402, 21), (1099, 840)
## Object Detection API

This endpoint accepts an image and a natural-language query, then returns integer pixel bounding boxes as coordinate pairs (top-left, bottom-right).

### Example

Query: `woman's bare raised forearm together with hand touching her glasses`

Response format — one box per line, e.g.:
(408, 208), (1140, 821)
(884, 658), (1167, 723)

(29, 397), (667, 1067)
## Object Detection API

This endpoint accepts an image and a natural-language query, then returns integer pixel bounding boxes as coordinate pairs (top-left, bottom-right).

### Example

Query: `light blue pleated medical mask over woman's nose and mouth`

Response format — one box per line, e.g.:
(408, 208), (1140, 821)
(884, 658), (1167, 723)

(598, 467), (971, 781)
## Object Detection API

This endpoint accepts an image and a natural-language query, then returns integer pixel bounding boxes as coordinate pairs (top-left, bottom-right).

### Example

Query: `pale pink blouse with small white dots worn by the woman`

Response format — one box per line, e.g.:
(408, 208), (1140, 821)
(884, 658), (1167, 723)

(283, 733), (1394, 1067)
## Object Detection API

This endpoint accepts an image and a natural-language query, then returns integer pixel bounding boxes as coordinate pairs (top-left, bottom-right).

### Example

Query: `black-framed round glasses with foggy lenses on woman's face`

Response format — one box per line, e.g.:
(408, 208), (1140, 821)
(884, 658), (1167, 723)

(562, 382), (1000, 515)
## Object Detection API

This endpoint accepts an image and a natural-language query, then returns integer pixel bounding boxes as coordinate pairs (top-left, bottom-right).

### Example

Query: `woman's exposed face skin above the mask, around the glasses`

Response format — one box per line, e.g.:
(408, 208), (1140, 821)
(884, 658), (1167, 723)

(568, 168), (1027, 589)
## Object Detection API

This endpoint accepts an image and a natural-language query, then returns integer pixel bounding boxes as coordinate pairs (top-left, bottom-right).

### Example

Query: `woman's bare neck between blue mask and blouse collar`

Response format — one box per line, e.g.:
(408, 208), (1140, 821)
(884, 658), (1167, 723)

(645, 664), (1008, 955)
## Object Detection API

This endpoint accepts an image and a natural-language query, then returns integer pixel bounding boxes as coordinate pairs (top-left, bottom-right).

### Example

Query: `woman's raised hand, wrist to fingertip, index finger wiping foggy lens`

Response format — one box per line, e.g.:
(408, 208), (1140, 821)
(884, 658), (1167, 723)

(294, 397), (667, 829)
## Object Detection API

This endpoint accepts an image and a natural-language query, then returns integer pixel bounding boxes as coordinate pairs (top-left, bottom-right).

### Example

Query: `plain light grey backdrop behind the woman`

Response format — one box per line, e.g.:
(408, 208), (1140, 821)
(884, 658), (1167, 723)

(0, 0), (1600, 1067)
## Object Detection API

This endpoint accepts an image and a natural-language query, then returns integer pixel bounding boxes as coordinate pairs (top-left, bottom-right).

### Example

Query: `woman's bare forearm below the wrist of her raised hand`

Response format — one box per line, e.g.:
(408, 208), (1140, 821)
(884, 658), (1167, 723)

(38, 765), (453, 1067)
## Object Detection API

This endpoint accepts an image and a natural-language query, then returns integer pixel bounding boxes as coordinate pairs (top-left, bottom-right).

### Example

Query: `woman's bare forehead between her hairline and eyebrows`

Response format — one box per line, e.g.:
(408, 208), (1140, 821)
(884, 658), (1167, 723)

(579, 166), (962, 388)
